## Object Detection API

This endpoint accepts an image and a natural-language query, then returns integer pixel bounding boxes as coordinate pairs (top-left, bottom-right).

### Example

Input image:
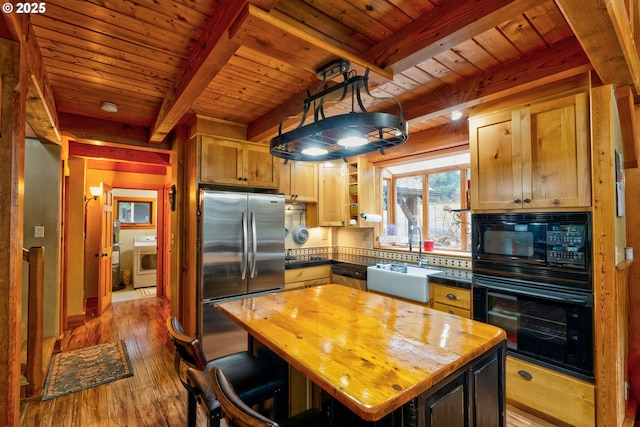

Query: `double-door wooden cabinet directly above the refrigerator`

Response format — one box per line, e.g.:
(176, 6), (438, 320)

(199, 135), (278, 188)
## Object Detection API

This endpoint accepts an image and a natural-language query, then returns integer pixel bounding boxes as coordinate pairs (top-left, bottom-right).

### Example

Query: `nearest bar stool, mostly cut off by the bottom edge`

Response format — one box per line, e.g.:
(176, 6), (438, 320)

(209, 367), (331, 427)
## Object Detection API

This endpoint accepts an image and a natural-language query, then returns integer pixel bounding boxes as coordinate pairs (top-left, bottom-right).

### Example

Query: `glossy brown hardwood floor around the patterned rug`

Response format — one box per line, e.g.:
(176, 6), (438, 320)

(20, 298), (552, 427)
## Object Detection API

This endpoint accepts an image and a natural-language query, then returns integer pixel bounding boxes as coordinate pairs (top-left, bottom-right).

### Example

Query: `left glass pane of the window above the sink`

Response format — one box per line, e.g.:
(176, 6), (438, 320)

(395, 176), (422, 244)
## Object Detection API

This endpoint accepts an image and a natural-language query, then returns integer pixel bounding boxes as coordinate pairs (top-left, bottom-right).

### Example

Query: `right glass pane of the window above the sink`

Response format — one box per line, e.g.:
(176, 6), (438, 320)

(428, 170), (464, 249)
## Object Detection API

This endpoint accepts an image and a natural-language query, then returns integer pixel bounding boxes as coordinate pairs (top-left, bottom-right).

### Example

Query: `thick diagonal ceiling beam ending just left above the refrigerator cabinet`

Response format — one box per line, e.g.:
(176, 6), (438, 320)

(149, 0), (277, 143)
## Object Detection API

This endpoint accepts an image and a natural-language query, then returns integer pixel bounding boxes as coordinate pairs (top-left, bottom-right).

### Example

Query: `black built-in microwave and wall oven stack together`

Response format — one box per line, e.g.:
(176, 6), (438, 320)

(472, 212), (594, 381)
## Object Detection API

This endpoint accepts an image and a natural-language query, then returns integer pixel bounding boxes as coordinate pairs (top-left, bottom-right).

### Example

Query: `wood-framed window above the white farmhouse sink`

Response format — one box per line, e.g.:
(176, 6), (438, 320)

(379, 154), (471, 251)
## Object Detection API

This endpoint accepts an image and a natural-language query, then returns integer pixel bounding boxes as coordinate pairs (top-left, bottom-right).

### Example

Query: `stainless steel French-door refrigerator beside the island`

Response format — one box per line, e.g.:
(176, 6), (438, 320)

(198, 189), (285, 359)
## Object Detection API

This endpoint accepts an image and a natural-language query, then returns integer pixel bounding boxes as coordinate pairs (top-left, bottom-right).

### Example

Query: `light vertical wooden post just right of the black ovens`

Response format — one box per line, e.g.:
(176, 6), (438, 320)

(591, 86), (626, 427)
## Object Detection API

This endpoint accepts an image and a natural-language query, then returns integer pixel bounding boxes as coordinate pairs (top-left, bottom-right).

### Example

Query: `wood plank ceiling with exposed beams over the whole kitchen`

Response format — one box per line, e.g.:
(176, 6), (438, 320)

(0, 0), (638, 165)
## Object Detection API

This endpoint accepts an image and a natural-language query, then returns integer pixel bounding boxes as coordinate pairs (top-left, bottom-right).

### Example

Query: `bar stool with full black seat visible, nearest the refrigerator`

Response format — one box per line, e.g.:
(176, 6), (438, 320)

(167, 316), (287, 427)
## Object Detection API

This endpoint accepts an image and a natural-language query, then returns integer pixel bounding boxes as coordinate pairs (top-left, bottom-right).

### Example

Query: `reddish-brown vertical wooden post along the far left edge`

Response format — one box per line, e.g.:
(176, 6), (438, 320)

(0, 39), (28, 427)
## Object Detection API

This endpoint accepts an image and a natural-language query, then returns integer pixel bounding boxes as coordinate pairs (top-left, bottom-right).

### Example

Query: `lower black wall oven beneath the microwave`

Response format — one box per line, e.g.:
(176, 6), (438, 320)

(473, 274), (594, 381)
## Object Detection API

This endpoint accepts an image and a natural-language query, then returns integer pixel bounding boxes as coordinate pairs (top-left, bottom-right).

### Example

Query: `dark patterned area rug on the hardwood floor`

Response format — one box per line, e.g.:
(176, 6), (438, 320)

(42, 341), (133, 400)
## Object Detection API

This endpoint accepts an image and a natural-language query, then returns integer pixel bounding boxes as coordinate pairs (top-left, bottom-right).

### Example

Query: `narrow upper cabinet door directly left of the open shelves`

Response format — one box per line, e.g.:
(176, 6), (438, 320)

(318, 160), (346, 227)
